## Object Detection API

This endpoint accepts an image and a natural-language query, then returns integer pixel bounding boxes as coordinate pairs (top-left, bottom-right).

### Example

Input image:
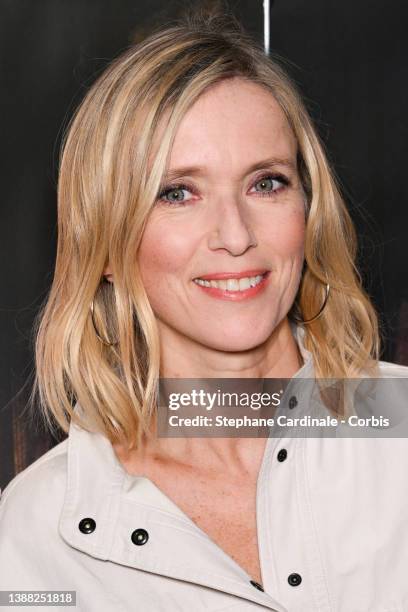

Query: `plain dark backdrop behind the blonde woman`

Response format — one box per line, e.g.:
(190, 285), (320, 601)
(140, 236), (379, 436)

(0, 0), (408, 488)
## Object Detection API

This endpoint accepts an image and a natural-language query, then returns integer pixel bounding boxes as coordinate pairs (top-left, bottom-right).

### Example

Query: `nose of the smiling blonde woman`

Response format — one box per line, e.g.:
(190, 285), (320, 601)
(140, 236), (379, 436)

(208, 197), (257, 256)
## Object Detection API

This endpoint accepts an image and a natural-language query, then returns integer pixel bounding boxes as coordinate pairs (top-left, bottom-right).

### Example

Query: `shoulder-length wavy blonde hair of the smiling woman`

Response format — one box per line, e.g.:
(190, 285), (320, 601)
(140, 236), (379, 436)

(32, 7), (379, 448)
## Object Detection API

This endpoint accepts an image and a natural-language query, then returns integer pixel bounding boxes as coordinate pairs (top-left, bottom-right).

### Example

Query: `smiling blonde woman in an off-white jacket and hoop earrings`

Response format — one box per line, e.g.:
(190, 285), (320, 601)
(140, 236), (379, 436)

(0, 9), (408, 612)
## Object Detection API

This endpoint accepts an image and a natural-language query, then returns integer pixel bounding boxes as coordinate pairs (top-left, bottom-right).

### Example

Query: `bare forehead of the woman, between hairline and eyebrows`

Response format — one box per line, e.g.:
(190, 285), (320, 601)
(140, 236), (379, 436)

(169, 78), (297, 172)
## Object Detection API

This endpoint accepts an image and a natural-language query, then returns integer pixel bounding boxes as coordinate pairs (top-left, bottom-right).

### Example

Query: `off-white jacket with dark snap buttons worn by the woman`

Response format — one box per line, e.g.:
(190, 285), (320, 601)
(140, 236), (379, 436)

(0, 328), (408, 612)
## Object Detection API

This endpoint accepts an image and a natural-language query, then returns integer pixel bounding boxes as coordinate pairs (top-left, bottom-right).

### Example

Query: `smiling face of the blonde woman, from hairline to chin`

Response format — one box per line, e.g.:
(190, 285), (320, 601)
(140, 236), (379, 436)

(138, 78), (305, 351)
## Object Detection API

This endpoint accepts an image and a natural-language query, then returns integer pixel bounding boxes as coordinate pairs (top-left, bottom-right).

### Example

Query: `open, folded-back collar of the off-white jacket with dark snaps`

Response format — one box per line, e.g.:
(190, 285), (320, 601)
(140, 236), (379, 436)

(59, 327), (312, 612)
